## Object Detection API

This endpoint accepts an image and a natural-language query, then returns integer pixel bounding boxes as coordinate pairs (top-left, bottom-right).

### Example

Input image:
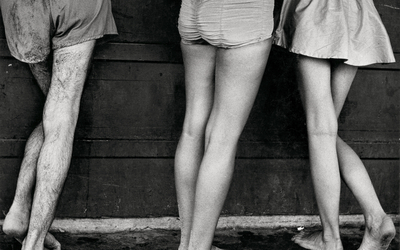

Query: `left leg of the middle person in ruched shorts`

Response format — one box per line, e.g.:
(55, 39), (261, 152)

(175, 44), (216, 250)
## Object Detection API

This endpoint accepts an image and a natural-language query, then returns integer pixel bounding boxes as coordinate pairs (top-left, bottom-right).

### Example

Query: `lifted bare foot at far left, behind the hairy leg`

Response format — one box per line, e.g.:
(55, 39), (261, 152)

(3, 202), (30, 237)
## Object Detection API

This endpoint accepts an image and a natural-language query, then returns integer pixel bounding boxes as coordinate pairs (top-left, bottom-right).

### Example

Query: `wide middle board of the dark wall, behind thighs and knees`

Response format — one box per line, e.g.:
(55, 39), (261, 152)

(0, 58), (400, 158)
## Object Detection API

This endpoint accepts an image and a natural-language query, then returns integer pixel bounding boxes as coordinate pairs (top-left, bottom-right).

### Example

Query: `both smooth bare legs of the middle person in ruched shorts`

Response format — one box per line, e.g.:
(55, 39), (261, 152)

(175, 40), (271, 250)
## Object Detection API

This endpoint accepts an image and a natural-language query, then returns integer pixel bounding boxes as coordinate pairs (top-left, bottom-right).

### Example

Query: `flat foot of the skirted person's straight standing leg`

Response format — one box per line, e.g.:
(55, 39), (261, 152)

(292, 231), (343, 250)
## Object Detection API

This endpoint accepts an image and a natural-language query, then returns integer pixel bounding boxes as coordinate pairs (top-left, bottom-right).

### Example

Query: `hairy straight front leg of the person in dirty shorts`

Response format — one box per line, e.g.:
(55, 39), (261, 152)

(22, 41), (95, 250)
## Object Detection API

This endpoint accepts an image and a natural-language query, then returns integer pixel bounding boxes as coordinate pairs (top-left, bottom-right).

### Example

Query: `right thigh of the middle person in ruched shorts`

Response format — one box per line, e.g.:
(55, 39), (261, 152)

(209, 39), (271, 136)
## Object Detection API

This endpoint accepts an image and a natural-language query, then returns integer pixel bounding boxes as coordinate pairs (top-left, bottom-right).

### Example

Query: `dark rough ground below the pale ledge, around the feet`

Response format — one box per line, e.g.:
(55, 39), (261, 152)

(0, 225), (400, 250)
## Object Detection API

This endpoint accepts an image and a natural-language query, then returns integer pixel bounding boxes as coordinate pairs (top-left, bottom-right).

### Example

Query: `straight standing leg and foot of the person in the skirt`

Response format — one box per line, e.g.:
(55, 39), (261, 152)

(294, 56), (343, 250)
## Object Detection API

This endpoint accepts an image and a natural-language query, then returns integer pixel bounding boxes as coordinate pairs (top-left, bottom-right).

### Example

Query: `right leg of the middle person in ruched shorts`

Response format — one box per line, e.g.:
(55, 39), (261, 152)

(189, 40), (271, 250)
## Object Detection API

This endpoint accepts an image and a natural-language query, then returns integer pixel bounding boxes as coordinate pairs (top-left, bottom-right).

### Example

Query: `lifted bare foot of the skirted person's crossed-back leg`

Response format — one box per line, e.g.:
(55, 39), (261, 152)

(359, 215), (396, 250)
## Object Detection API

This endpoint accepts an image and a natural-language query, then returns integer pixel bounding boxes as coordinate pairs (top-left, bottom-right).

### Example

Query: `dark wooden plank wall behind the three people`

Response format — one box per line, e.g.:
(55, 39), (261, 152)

(0, 0), (400, 218)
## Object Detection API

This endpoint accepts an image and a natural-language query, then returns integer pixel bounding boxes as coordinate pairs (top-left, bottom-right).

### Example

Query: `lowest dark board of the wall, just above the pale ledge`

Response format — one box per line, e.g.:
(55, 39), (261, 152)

(0, 158), (400, 218)
